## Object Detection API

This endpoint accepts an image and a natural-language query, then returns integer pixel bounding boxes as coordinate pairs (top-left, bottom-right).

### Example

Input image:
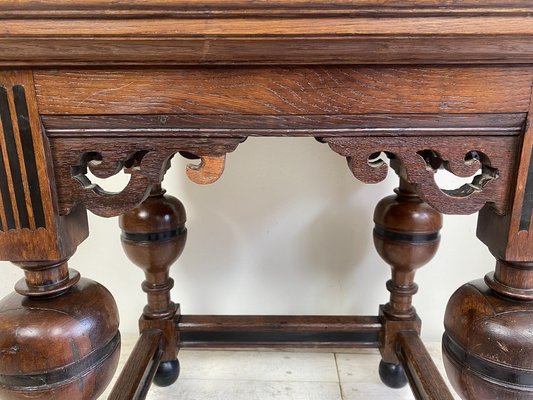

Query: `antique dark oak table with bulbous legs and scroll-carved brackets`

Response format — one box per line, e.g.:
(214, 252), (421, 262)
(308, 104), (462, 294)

(0, 0), (533, 400)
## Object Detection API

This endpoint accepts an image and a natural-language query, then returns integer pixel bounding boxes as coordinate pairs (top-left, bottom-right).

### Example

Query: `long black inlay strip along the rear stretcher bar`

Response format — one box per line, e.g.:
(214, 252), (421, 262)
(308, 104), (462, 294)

(179, 331), (379, 345)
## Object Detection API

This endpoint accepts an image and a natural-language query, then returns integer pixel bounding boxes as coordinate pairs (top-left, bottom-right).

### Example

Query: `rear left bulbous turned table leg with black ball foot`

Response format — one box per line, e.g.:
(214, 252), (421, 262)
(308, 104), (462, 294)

(120, 185), (187, 386)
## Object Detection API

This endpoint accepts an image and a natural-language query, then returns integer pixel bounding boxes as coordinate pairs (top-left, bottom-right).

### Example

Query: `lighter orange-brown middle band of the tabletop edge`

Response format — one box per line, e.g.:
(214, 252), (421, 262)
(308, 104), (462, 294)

(7, 16), (533, 40)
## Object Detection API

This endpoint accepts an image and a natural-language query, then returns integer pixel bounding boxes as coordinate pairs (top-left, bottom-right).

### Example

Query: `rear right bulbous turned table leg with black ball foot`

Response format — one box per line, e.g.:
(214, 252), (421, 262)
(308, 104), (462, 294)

(374, 179), (442, 388)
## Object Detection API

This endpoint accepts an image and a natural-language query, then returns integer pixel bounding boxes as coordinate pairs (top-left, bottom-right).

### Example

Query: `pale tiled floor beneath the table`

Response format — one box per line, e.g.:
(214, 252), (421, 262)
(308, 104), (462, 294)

(102, 337), (459, 400)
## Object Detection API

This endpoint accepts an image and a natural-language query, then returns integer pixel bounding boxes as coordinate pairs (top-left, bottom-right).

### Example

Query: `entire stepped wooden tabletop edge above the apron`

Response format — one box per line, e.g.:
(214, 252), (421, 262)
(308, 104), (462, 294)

(0, 0), (533, 66)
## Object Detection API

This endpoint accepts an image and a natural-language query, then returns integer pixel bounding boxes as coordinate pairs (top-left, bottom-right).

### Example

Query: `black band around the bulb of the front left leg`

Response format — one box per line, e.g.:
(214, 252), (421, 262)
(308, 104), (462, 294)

(0, 332), (120, 388)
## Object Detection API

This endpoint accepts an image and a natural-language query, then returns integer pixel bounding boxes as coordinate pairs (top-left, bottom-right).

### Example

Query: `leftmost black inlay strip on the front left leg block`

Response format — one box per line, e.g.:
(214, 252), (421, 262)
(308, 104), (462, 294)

(0, 87), (30, 228)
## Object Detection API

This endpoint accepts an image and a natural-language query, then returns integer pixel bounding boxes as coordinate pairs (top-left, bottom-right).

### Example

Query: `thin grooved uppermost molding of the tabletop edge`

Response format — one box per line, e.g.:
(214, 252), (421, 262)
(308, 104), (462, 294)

(0, 0), (533, 18)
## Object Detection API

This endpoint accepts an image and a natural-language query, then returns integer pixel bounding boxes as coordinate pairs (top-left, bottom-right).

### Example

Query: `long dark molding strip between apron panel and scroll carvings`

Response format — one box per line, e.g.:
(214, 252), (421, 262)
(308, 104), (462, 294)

(41, 113), (527, 138)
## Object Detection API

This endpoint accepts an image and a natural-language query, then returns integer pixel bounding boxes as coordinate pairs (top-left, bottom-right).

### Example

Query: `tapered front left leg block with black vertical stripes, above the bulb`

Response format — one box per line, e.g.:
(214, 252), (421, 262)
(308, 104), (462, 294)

(0, 71), (88, 261)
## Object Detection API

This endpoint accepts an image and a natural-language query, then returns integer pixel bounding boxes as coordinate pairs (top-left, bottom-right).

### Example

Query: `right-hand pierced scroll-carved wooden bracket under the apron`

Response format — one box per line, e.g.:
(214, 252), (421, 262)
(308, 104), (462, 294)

(324, 136), (518, 214)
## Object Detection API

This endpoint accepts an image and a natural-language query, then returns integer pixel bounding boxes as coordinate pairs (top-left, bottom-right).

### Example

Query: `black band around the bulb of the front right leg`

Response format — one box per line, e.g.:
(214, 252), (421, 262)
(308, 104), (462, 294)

(442, 334), (533, 387)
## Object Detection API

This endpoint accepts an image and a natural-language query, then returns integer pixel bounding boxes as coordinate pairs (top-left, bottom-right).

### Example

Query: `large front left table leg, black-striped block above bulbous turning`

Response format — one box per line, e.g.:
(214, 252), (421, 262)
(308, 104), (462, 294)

(0, 69), (120, 400)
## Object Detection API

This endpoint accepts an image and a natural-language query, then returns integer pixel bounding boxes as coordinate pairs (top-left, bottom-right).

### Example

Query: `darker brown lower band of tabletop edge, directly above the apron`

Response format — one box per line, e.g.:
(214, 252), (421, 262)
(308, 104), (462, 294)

(4, 34), (533, 67)
